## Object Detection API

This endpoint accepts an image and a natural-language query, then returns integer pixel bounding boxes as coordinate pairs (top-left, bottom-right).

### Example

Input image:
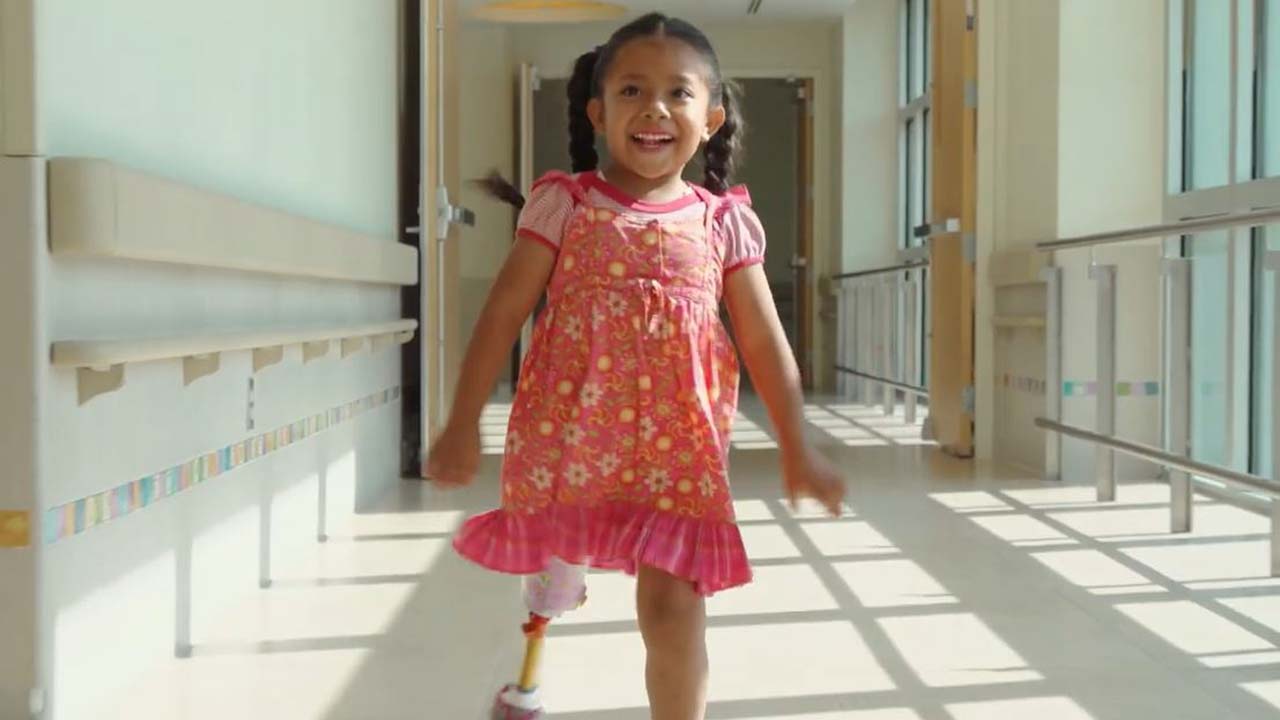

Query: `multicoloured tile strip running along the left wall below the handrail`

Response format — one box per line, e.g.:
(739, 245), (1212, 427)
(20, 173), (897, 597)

(44, 387), (401, 544)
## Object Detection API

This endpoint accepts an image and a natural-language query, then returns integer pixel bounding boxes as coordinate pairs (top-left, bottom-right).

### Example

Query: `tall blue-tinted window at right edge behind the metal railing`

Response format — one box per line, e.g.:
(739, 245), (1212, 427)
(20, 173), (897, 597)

(1165, 0), (1280, 475)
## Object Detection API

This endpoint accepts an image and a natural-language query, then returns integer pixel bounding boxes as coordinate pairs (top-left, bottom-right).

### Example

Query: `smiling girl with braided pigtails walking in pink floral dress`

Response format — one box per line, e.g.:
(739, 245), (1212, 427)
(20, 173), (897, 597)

(426, 14), (844, 720)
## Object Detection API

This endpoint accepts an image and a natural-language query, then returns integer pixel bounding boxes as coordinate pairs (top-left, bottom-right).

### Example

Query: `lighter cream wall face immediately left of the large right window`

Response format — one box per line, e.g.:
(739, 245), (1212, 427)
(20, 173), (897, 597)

(1057, 0), (1166, 479)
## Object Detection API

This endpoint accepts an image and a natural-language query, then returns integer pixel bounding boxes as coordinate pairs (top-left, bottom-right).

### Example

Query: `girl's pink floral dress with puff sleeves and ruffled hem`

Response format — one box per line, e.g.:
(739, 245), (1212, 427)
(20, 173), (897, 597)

(454, 173), (764, 594)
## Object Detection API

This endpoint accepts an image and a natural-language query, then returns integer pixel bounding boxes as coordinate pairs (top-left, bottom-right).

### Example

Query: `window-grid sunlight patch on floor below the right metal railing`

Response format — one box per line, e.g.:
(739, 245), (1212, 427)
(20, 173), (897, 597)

(932, 483), (1280, 696)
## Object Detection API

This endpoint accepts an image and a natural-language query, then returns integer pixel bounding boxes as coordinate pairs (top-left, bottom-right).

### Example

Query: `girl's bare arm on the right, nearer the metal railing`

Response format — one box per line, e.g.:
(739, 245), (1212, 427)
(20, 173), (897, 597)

(724, 265), (845, 515)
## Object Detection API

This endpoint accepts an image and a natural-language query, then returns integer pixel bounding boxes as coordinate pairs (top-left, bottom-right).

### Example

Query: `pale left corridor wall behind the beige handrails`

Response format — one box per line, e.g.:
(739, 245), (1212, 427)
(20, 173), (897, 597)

(0, 0), (401, 717)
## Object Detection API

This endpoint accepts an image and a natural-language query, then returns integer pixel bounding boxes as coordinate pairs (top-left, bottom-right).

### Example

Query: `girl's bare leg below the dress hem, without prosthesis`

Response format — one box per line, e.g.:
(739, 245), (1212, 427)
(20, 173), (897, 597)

(636, 566), (708, 720)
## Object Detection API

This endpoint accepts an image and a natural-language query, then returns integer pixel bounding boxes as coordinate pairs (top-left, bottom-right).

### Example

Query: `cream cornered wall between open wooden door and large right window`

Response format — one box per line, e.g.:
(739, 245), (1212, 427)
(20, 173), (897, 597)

(977, 0), (1165, 471)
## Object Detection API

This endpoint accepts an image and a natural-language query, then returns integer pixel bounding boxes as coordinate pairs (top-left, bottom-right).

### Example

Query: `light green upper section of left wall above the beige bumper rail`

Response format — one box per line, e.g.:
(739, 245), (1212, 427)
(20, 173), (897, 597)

(36, 0), (398, 234)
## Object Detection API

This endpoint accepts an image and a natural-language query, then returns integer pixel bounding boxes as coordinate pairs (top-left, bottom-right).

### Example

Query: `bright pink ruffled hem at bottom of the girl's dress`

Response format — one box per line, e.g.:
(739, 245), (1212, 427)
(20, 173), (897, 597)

(453, 503), (751, 596)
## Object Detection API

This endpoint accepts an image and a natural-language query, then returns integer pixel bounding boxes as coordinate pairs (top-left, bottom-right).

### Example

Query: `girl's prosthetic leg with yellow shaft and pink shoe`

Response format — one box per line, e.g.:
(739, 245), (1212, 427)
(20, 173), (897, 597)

(493, 559), (586, 720)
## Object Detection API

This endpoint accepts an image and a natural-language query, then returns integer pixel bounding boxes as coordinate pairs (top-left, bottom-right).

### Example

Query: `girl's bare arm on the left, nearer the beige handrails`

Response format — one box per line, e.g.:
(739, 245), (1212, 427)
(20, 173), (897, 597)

(425, 238), (556, 486)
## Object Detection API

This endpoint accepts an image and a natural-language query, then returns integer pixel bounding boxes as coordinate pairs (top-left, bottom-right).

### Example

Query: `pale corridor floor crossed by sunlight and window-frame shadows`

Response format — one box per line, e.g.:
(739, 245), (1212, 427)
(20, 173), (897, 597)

(136, 404), (1280, 720)
